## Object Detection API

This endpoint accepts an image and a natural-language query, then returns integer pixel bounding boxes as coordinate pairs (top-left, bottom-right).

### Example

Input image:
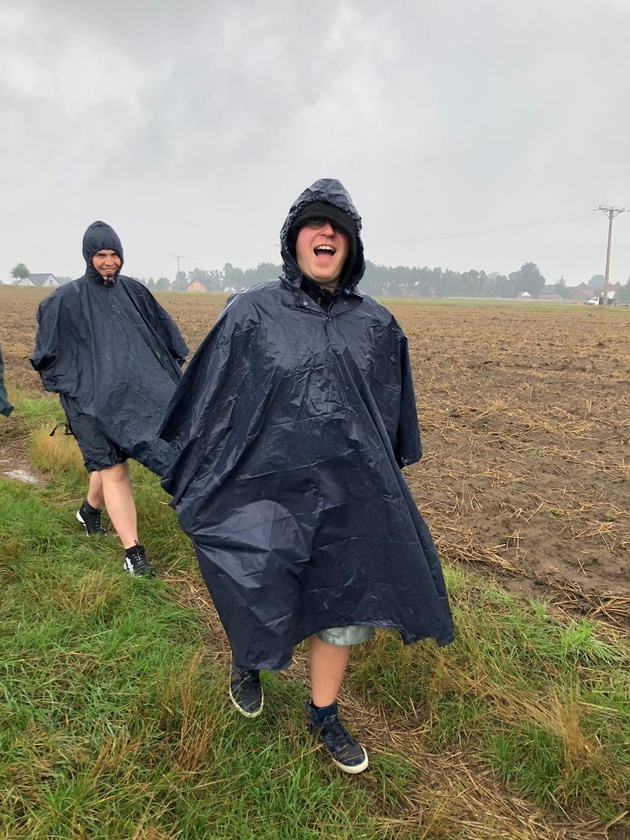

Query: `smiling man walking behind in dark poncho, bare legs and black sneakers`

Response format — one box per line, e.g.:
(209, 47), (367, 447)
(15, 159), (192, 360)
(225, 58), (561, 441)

(31, 222), (188, 575)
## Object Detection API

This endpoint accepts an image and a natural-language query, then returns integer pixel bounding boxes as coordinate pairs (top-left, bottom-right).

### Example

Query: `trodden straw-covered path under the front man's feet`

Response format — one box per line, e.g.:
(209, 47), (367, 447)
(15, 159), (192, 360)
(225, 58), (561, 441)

(165, 572), (623, 840)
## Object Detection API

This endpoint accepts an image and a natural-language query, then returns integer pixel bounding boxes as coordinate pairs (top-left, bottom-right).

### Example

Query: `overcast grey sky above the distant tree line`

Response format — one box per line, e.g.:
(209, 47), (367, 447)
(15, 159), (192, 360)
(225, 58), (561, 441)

(0, 0), (630, 285)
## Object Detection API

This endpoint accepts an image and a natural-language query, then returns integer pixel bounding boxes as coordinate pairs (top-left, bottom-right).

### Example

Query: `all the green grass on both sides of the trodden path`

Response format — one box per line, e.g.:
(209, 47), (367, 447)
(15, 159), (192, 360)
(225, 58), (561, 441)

(0, 397), (630, 840)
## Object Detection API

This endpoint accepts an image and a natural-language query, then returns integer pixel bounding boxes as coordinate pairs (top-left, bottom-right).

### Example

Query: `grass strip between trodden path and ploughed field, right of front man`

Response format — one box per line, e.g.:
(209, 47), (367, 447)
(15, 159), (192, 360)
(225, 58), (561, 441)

(350, 568), (630, 820)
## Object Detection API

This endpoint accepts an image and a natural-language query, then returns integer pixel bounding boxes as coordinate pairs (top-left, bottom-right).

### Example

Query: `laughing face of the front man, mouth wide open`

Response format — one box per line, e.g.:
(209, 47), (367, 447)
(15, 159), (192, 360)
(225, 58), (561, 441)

(295, 219), (349, 287)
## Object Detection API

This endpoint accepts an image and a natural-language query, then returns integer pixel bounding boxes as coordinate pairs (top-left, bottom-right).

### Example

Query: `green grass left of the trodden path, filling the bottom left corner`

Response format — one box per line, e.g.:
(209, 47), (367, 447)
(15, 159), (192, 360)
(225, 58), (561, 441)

(0, 472), (390, 838)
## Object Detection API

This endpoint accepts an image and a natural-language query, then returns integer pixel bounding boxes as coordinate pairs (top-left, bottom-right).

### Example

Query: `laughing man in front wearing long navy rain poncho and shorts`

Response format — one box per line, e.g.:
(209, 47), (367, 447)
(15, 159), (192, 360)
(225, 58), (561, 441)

(161, 179), (453, 773)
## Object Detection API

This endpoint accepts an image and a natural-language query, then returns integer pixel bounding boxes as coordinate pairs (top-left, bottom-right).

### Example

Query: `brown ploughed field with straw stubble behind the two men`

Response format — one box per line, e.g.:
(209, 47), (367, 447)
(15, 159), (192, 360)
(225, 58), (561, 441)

(0, 287), (630, 624)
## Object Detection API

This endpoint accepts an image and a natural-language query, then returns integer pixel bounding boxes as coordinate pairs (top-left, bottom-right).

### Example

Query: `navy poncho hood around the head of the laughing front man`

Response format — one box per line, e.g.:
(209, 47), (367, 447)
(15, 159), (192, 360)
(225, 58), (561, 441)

(280, 178), (365, 290)
